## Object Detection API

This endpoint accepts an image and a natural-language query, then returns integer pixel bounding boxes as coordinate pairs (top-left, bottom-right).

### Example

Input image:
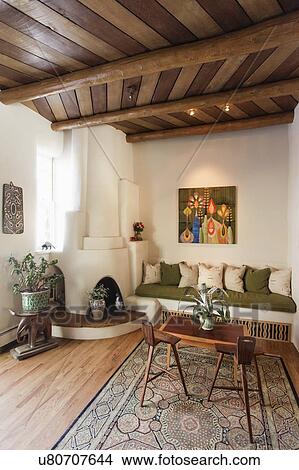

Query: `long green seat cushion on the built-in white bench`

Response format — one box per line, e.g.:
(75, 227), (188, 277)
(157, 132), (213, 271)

(135, 284), (297, 313)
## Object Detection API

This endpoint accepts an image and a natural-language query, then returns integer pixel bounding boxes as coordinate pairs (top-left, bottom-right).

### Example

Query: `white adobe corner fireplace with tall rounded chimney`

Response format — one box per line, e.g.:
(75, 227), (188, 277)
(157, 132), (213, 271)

(49, 126), (159, 339)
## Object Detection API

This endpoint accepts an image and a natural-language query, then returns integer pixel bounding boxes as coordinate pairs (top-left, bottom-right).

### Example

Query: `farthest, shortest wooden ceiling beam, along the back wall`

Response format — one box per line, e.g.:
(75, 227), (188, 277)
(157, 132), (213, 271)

(126, 111), (294, 143)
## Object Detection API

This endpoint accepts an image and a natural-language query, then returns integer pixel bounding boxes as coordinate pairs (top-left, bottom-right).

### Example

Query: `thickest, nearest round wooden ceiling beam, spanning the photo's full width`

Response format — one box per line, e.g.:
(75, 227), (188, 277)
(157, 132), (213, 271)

(0, 11), (299, 104)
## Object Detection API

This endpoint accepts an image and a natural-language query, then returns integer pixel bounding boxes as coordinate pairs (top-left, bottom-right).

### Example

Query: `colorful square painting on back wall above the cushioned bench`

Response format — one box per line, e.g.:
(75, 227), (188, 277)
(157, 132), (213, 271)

(178, 186), (236, 245)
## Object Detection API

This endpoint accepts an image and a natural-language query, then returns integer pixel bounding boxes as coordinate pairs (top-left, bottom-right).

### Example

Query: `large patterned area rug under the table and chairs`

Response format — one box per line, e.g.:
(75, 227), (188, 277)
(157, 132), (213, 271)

(54, 343), (299, 450)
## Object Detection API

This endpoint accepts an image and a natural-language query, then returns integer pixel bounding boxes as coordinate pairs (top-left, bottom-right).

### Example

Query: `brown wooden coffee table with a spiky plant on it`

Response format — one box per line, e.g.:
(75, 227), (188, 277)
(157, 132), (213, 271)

(160, 315), (248, 367)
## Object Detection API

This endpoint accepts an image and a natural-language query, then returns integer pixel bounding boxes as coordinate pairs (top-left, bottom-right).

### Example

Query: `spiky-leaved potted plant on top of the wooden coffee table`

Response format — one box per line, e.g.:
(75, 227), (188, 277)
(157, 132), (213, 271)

(186, 284), (230, 331)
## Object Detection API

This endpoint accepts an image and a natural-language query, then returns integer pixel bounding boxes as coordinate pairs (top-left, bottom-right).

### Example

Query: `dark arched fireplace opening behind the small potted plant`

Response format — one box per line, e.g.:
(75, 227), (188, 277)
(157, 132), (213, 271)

(87, 276), (125, 319)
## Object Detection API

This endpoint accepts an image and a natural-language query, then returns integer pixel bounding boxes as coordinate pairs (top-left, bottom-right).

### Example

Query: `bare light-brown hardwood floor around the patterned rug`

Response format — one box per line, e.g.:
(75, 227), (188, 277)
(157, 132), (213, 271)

(0, 331), (299, 449)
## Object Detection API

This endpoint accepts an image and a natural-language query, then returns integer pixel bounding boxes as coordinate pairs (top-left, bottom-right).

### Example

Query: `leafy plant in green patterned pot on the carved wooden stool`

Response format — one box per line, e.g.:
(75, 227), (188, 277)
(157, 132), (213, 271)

(9, 253), (62, 313)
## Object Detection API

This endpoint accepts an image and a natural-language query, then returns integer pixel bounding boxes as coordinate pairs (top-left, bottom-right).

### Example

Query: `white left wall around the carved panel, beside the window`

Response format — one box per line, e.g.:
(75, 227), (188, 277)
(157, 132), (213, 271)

(0, 104), (62, 344)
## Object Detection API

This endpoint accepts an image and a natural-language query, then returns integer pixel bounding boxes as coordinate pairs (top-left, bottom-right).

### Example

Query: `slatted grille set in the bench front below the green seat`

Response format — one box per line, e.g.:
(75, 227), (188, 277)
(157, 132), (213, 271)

(162, 310), (292, 341)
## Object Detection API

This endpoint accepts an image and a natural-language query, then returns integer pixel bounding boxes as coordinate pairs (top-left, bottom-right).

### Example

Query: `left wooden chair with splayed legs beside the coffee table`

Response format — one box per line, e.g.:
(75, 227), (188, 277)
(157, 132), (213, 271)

(141, 321), (188, 406)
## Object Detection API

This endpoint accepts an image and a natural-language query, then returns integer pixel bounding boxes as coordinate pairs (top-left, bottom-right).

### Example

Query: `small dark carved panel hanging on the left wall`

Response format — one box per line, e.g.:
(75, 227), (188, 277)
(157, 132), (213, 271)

(2, 181), (24, 234)
